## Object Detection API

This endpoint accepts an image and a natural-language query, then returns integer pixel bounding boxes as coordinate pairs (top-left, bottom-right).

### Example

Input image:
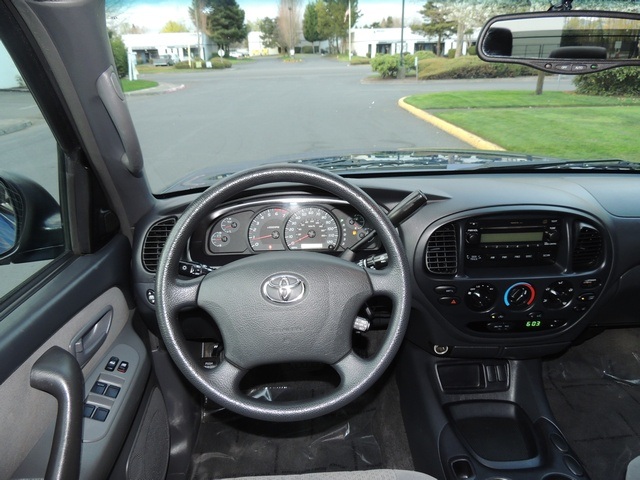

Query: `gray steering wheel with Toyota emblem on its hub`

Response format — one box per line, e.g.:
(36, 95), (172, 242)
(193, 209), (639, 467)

(156, 165), (410, 421)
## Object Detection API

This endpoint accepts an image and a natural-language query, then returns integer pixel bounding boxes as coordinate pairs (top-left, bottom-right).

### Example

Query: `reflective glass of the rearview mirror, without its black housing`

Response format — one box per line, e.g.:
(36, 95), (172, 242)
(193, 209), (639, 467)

(481, 14), (640, 60)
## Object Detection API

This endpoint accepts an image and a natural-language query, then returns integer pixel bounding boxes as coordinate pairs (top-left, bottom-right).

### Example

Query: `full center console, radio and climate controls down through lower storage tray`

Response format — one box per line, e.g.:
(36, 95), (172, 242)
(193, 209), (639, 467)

(396, 207), (600, 480)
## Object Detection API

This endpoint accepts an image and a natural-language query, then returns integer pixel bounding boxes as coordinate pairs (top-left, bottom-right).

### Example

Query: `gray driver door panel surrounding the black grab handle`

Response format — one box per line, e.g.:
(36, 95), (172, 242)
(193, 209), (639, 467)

(0, 237), (150, 478)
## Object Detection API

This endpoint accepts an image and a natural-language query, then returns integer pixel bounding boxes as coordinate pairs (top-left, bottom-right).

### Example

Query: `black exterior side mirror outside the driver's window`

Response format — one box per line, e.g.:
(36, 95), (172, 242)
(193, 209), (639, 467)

(0, 172), (64, 264)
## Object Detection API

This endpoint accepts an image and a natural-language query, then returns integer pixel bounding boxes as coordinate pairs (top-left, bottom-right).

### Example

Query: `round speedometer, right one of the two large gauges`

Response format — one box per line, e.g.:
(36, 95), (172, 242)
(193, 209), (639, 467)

(284, 207), (340, 250)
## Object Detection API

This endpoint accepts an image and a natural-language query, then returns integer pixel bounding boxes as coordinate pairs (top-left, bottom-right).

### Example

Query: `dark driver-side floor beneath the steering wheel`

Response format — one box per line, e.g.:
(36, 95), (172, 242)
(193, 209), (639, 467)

(190, 366), (413, 480)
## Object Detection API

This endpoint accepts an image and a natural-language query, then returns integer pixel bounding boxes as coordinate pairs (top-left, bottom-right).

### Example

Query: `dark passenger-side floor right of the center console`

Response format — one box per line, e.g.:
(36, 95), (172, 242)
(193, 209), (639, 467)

(543, 328), (640, 480)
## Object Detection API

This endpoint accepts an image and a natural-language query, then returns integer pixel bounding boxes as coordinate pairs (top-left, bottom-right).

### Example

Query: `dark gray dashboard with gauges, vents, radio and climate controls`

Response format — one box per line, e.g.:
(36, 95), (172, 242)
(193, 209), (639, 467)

(134, 173), (640, 358)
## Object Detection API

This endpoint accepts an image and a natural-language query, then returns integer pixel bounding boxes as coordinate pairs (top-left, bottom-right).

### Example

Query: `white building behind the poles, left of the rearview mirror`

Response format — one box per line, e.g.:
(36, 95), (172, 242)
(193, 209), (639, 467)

(351, 27), (455, 58)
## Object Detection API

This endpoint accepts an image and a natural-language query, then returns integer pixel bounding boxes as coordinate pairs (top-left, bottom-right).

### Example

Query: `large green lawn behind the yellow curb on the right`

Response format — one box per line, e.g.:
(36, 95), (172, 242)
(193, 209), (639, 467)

(406, 91), (640, 161)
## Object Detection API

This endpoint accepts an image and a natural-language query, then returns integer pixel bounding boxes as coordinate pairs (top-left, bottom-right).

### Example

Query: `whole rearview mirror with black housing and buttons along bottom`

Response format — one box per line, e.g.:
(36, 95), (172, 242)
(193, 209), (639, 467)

(478, 10), (640, 75)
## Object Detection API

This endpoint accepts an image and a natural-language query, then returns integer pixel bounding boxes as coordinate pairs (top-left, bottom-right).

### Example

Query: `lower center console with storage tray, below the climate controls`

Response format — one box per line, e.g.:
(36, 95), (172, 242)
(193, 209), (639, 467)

(396, 343), (588, 480)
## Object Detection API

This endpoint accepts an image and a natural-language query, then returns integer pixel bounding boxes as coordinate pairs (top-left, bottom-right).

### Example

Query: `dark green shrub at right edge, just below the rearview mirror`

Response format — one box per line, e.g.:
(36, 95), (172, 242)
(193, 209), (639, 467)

(573, 67), (640, 97)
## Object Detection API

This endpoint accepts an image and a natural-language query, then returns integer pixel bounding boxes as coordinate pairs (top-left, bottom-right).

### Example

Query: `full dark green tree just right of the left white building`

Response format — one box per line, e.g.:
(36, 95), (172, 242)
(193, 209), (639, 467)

(205, 0), (247, 53)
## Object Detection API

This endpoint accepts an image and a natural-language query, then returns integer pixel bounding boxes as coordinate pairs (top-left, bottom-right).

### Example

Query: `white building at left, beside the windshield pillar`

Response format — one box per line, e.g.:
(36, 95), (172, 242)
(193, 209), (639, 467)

(122, 32), (218, 63)
